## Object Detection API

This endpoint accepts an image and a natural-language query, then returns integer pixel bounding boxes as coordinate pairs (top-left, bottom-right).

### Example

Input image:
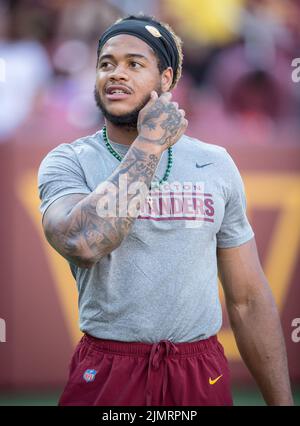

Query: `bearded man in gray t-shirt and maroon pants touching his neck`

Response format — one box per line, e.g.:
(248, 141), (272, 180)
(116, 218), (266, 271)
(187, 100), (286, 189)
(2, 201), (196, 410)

(39, 15), (292, 405)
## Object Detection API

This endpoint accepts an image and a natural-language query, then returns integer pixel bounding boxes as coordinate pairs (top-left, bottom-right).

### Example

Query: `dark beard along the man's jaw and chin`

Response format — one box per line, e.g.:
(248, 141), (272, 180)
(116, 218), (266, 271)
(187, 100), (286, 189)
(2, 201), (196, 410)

(94, 84), (162, 130)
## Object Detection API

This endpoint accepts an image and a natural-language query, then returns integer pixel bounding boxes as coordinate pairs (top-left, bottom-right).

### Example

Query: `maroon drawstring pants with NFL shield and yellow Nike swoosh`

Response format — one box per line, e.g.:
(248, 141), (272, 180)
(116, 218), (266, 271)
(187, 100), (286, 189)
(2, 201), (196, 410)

(59, 335), (232, 406)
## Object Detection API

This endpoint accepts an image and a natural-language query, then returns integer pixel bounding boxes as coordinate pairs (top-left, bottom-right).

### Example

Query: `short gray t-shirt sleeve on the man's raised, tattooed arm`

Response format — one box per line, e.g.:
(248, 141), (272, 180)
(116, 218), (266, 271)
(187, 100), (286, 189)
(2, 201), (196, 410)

(38, 144), (91, 215)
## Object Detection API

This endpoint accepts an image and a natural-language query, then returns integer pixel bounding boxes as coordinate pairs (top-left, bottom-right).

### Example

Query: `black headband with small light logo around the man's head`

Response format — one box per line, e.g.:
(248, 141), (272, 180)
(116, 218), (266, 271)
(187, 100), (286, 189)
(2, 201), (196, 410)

(98, 19), (179, 81)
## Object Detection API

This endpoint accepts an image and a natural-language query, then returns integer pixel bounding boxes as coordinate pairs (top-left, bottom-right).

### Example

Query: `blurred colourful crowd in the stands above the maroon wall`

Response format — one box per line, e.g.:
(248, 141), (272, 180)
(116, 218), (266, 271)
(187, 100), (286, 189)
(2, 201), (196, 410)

(0, 0), (300, 146)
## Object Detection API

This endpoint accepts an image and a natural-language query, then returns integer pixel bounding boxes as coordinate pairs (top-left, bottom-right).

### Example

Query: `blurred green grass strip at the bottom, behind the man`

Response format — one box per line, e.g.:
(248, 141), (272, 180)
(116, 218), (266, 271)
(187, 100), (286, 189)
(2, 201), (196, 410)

(0, 388), (300, 406)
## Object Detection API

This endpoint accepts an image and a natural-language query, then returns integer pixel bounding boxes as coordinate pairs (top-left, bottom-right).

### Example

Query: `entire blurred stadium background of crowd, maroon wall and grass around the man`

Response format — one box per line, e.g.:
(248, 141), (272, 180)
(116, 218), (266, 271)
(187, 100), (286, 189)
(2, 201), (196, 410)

(0, 0), (300, 405)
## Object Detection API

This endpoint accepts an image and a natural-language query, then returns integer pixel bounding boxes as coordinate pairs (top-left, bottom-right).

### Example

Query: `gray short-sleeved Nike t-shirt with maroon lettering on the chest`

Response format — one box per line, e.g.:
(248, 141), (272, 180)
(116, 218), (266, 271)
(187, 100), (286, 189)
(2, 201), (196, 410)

(38, 131), (254, 343)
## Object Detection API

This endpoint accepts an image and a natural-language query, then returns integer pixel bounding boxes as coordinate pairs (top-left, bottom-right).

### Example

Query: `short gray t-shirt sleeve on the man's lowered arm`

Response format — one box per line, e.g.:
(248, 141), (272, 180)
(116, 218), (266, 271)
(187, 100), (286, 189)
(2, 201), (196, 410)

(217, 151), (254, 248)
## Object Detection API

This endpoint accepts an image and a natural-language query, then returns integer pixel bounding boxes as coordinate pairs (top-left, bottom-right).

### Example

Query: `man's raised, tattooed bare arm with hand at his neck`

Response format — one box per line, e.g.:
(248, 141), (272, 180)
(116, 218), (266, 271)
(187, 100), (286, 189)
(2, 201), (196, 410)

(43, 92), (187, 268)
